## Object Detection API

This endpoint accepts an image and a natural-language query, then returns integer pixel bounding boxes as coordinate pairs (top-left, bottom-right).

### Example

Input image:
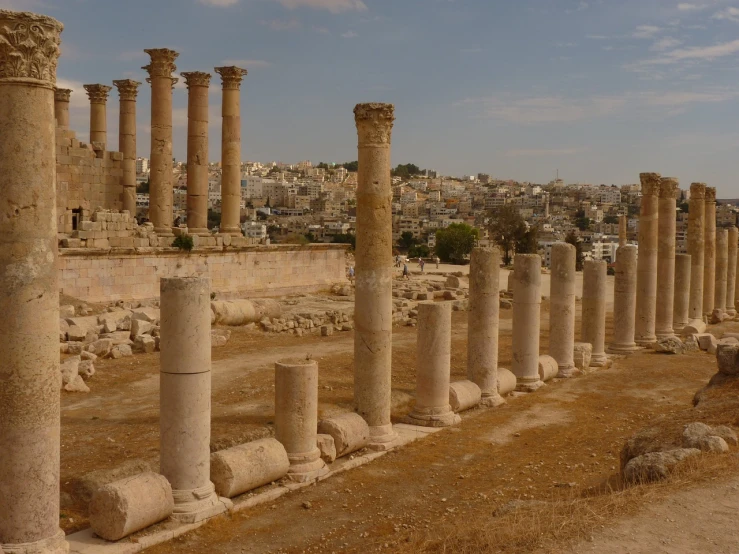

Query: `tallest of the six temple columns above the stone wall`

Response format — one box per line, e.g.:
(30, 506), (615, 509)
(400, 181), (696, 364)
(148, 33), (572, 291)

(142, 48), (179, 236)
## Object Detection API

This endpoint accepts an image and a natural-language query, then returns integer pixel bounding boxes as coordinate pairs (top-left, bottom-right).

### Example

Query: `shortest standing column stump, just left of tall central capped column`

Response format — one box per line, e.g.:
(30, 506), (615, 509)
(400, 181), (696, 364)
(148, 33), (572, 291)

(275, 359), (328, 482)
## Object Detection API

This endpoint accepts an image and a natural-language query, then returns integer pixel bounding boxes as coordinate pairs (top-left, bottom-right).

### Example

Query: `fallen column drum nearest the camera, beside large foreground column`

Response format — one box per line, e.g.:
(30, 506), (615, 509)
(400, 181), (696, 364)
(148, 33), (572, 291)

(90, 472), (174, 541)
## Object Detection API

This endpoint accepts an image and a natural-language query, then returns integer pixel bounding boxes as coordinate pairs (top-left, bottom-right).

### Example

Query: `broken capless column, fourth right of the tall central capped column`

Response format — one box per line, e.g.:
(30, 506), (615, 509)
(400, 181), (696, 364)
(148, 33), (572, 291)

(549, 242), (579, 377)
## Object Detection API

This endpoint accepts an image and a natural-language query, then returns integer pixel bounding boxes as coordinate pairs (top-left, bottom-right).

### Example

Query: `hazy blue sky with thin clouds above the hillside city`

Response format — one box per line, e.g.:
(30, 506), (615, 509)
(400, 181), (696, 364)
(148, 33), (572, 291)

(0, 0), (739, 197)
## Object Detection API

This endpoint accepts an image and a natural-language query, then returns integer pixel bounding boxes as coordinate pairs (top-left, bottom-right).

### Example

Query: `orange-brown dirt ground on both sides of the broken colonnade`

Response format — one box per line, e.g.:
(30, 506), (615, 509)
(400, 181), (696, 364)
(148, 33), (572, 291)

(61, 286), (739, 554)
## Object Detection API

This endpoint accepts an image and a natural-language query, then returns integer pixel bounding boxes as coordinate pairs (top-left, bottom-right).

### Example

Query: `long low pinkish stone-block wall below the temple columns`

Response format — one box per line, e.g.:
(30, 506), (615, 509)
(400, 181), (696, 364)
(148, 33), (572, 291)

(59, 245), (346, 302)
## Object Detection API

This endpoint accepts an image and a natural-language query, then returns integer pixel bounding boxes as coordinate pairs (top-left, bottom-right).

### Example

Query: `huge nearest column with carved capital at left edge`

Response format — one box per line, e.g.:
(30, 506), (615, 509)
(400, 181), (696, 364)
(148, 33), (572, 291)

(0, 10), (69, 554)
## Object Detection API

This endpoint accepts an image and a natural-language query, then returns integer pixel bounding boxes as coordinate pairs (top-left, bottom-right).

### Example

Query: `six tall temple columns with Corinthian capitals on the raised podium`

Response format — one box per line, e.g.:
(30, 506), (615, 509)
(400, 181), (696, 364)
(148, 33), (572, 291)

(54, 48), (247, 236)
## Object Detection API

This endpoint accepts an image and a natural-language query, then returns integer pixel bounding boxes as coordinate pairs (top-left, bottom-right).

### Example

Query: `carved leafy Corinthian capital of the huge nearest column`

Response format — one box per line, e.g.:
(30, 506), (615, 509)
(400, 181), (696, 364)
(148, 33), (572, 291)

(0, 10), (64, 87)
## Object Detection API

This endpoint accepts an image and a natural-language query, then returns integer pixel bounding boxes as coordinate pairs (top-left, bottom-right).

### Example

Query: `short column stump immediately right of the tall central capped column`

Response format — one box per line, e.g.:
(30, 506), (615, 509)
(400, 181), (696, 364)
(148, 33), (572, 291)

(407, 302), (461, 427)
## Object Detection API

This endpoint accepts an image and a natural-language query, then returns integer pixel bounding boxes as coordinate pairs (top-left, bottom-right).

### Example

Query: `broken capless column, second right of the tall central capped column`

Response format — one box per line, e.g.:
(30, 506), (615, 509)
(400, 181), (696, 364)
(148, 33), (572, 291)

(467, 248), (505, 406)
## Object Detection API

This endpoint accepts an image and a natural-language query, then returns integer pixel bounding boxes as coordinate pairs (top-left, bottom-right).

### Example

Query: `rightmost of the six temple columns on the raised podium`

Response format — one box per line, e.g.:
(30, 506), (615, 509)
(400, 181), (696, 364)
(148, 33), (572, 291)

(216, 66), (246, 236)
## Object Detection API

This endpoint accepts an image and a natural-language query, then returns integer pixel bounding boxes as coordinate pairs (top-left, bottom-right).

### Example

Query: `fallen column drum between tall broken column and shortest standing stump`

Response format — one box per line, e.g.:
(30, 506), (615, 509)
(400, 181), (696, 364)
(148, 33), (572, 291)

(210, 438), (290, 498)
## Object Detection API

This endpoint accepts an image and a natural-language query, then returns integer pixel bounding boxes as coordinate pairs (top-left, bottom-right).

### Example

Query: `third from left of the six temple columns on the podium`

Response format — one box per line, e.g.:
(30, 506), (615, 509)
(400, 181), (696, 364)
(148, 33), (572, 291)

(113, 79), (141, 217)
